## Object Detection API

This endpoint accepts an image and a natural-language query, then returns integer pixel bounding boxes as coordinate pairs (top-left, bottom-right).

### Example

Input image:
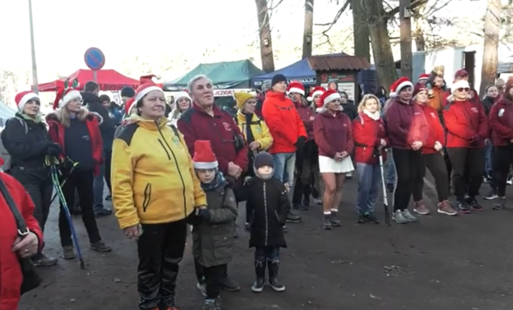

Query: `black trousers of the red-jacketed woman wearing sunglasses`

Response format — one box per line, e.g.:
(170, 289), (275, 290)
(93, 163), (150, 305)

(447, 147), (485, 200)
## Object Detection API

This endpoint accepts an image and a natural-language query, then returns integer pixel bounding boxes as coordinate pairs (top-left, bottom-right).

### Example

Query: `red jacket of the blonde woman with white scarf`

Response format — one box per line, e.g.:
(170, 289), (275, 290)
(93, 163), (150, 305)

(353, 113), (388, 165)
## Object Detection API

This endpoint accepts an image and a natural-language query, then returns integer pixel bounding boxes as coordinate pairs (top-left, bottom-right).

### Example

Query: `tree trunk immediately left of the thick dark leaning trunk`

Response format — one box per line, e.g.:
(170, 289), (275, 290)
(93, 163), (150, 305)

(352, 0), (370, 62)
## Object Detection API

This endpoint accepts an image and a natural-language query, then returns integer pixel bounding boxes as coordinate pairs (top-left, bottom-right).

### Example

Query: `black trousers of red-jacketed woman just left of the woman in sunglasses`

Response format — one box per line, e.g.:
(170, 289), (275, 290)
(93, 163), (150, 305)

(413, 152), (449, 202)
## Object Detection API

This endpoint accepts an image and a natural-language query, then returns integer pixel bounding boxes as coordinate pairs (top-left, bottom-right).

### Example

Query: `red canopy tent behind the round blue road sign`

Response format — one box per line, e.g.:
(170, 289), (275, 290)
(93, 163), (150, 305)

(37, 69), (139, 92)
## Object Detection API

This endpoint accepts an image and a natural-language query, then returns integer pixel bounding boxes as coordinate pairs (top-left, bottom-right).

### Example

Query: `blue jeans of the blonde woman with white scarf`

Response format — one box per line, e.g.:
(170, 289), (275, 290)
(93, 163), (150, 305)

(356, 163), (381, 214)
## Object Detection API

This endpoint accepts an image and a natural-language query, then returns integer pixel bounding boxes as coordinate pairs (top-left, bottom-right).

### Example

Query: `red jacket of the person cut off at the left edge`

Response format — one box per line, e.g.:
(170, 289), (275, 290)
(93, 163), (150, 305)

(0, 172), (43, 310)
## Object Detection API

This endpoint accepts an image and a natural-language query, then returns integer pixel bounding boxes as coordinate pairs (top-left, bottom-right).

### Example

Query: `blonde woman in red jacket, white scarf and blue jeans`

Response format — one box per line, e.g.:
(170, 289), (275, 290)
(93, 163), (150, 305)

(353, 95), (387, 224)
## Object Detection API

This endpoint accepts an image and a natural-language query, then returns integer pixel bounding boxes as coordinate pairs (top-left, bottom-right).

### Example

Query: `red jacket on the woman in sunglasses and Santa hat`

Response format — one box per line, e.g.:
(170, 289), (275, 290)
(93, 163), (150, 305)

(444, 100), (488, 148)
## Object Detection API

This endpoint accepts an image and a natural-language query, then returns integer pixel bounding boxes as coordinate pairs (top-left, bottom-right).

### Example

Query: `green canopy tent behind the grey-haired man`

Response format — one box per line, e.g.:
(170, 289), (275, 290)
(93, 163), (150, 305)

(164, 59), (265, 91)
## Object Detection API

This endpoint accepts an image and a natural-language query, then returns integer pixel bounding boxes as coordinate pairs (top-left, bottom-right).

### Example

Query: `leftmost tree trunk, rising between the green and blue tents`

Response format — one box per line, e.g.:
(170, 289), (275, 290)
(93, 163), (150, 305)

(255, 0), (274, 72)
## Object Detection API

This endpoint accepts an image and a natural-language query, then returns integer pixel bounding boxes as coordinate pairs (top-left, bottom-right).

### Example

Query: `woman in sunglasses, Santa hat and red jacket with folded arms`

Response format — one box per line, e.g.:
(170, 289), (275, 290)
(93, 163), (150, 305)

(443, 79), (488, 213)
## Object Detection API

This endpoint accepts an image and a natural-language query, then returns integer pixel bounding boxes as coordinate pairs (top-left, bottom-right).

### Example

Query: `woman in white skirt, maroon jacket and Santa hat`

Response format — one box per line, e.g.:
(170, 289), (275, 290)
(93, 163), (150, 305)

(314, 90), (354, 230)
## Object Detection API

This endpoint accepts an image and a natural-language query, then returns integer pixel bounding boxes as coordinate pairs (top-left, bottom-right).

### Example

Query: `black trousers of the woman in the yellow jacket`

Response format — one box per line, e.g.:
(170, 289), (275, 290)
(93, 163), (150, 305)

(137, 219), (187, 310)
